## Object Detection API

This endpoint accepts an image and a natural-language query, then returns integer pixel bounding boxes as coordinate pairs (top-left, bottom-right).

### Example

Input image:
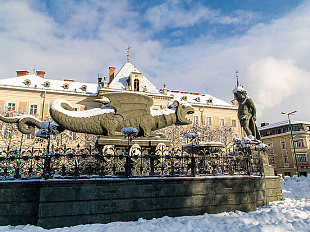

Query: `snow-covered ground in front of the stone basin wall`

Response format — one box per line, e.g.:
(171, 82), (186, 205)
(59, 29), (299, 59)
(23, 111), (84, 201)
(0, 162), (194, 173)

(0, 177), (310, 232)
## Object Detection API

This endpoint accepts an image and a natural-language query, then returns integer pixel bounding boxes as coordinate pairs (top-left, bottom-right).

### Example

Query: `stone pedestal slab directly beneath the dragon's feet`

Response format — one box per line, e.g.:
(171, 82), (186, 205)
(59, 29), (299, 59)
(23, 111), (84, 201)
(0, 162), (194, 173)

(96, 136), (171, 147)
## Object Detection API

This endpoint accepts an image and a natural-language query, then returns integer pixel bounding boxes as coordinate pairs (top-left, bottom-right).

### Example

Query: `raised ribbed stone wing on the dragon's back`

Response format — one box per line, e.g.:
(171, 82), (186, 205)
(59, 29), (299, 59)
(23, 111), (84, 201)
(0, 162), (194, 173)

(103, 92), (154, 120)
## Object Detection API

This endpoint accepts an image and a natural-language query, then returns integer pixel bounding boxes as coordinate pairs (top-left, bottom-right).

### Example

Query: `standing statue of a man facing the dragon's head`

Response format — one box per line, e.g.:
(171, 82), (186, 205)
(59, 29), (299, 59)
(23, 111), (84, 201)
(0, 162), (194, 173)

(233, 86), (261, 140)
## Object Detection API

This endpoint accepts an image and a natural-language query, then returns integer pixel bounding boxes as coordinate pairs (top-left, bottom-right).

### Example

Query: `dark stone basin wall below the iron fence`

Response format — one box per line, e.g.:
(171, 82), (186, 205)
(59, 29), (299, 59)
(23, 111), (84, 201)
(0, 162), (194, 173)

(0, 176), (281, 228)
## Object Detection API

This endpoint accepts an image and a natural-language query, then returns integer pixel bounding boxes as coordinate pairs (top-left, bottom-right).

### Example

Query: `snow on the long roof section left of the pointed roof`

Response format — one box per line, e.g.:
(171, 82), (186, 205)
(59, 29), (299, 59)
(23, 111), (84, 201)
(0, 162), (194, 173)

(0, 74), (99, 95)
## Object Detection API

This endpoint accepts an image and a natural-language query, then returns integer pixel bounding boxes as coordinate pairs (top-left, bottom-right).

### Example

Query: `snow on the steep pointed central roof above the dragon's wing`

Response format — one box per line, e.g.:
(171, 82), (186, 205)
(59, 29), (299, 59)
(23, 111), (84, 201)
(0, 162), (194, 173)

(109, 61), (159, 93)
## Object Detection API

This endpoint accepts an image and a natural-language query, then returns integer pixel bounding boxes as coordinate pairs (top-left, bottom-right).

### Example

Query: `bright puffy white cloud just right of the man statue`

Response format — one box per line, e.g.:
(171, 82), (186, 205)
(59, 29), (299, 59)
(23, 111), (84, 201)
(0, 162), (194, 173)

(248, 57), (310, 116)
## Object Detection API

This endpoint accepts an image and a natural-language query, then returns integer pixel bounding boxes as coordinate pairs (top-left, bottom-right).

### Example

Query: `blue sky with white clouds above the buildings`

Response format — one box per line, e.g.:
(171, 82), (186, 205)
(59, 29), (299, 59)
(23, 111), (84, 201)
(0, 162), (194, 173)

(0, 0), (310, 122)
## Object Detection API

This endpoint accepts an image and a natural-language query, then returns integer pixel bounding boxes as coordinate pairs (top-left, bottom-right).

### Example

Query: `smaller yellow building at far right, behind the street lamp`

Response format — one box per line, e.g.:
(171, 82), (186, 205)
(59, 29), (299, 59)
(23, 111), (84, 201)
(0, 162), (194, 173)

(259, 120), (310, 176)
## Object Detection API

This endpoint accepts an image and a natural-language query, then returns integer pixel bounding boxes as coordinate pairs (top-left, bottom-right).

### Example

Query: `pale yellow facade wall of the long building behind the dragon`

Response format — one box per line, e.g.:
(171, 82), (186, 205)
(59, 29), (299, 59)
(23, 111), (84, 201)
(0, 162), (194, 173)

(0, 74), (241, 150)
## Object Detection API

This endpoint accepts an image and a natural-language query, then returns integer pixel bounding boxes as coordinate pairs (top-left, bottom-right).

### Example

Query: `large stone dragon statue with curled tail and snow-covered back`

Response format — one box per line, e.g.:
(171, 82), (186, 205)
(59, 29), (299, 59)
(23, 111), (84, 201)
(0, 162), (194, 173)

(0, 92), (194, 136)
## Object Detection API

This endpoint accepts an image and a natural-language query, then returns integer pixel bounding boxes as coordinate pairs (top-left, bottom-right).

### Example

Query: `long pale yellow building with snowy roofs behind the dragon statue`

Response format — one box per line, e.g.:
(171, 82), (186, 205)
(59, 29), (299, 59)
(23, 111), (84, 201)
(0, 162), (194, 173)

(0, 59), (241, 150)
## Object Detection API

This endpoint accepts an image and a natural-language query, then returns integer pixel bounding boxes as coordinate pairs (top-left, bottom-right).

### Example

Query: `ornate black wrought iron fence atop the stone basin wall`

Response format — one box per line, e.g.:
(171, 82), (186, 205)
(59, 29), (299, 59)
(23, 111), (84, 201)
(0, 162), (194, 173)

(0, 147), (263, 180)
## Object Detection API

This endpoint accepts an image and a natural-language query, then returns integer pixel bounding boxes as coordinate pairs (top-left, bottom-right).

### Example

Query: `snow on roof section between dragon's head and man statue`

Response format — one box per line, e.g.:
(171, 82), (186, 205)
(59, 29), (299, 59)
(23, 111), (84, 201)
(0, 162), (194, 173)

(168, 91), (237, 108)
